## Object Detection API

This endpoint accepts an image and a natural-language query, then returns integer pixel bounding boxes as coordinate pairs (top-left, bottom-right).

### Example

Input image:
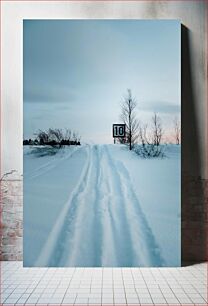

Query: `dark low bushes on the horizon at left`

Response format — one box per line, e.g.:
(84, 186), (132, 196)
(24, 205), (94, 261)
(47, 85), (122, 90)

(23, 128), (81, 148)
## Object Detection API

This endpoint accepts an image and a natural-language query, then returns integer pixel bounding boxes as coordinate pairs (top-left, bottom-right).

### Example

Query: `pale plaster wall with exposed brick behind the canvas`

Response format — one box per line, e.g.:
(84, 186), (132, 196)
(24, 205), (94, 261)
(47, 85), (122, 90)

(0, 1), (208, 263)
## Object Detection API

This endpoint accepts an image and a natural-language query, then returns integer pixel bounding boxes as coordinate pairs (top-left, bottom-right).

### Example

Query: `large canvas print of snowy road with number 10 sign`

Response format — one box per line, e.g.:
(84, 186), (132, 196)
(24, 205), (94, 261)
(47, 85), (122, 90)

(23, 20), (181, 267)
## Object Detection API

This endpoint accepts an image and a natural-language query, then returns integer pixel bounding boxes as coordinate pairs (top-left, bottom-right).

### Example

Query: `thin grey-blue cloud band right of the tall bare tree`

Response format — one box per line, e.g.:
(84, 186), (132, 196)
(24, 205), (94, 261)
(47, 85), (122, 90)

(138, 101), (181, 114)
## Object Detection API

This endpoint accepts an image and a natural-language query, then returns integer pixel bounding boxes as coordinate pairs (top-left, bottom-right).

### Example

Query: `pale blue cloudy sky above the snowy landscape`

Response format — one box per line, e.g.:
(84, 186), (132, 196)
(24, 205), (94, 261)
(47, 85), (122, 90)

(23, 20), (181, 143)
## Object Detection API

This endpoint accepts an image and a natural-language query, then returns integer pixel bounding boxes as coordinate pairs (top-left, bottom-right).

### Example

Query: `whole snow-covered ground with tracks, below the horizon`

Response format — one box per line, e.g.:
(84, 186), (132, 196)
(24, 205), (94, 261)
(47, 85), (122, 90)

(24, 145), (181, 267)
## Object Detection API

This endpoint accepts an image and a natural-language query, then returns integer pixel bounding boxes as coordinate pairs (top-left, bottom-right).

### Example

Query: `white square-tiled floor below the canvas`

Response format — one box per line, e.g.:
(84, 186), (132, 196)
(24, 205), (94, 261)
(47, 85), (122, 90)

(0, 262), (207, 306)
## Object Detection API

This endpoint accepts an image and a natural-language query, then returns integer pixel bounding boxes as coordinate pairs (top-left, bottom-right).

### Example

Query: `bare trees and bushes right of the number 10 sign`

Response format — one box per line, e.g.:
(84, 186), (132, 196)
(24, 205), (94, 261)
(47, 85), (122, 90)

(119, 89), (181, 157)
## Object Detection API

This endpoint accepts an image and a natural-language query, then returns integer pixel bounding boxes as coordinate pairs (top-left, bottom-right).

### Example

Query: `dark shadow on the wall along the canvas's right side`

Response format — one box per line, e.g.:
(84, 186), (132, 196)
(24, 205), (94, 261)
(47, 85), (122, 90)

(181, 25), (208, 266)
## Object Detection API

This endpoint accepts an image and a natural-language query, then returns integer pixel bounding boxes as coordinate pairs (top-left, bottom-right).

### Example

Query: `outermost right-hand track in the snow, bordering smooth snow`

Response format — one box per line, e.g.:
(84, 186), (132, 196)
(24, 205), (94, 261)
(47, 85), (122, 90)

(105, 146), (164, 266)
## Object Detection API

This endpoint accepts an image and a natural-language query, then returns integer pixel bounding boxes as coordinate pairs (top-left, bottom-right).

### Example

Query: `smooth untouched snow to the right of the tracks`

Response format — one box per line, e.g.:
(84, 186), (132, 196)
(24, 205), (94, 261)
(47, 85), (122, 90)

(105, 145), (181, 266)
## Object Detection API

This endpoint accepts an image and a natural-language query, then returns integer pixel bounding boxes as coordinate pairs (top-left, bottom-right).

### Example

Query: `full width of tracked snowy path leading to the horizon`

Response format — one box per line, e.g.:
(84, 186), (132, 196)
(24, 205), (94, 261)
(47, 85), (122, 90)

(36, 145), (164, 267)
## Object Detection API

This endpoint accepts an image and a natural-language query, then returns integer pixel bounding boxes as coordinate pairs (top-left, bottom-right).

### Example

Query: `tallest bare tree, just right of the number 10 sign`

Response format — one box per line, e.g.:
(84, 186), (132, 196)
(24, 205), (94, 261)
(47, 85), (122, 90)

(121, 89), (139, 150)
